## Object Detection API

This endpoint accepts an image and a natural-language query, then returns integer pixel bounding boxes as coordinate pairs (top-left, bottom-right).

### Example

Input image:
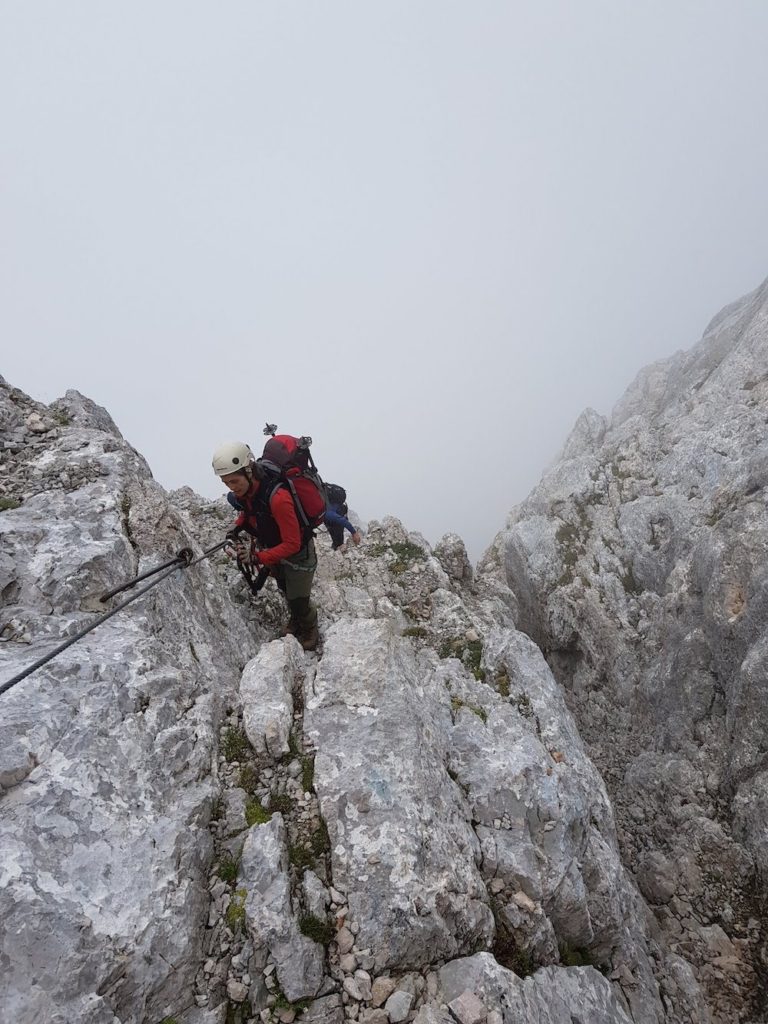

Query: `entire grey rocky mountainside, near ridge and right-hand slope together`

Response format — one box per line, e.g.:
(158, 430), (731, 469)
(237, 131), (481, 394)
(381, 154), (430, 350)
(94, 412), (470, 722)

(0, 272), (768, 1024)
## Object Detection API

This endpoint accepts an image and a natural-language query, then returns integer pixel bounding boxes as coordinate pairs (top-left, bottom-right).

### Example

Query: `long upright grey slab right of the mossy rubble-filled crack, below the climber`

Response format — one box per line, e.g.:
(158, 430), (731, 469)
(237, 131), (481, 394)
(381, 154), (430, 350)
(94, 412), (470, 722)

(304, 620), (494, 970)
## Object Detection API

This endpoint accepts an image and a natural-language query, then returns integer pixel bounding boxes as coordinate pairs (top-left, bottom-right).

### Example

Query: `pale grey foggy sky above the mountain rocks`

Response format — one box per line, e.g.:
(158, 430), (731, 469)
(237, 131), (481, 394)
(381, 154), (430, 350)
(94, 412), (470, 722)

(0, 0), (768, 558)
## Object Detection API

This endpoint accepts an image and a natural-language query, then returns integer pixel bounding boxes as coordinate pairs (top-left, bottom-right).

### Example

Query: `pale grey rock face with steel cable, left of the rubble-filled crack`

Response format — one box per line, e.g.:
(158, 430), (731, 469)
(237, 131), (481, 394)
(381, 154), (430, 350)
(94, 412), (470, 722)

(0, 382), (258, 1024)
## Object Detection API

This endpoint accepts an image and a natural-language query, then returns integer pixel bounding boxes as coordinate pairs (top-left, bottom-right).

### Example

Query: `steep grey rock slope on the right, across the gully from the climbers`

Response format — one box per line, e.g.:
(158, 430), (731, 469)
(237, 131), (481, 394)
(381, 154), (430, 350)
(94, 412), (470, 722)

(480, 274), (768, 1021)
